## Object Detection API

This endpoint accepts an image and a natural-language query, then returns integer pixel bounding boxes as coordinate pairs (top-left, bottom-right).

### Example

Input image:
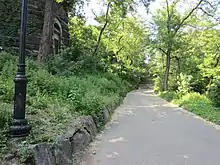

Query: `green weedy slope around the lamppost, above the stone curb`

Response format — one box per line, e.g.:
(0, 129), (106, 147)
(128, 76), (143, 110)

(0, 53), (132, 160)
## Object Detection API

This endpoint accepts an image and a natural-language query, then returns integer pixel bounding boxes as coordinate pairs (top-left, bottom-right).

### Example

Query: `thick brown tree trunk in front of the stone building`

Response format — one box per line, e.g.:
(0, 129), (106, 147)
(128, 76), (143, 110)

(37, 0), (55, 63)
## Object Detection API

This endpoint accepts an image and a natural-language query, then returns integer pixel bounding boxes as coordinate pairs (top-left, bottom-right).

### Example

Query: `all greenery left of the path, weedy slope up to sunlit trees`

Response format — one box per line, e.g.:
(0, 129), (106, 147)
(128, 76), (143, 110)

(0, 0), (149, 161)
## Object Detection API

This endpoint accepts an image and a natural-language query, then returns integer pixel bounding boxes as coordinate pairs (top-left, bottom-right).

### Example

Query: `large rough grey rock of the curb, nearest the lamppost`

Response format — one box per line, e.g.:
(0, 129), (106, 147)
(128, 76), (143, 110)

(28, 116), (97, 165)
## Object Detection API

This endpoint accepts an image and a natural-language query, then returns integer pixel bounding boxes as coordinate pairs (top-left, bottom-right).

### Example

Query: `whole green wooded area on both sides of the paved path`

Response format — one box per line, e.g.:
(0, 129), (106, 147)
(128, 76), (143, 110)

(0, 0), (220, 161)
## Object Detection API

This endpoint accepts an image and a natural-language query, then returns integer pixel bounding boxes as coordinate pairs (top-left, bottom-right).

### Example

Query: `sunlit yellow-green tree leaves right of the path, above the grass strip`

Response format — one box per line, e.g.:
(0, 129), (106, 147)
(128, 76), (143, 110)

(152, 0), (219, 93)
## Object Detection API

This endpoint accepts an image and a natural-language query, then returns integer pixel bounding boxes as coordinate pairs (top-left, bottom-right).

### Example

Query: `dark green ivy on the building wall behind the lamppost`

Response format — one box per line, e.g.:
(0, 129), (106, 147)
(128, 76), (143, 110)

(0, 0), (41, 51)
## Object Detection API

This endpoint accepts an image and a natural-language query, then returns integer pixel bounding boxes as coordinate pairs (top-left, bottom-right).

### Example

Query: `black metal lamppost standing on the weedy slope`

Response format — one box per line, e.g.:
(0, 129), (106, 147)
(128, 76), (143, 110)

(10, 0), (31, 137)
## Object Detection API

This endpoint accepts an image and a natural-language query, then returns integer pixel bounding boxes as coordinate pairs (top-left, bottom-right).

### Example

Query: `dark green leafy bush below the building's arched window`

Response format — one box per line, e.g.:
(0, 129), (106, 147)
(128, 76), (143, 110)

(46, 48), (105, 76)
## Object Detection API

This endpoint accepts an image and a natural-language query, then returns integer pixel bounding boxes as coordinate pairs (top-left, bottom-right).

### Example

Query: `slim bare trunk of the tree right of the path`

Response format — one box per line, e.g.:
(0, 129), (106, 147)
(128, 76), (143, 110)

(163, 50), (171, 91)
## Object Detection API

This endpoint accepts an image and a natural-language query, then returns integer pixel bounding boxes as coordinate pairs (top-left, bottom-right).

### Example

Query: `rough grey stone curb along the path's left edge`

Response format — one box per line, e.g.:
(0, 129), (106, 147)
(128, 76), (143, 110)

(4, 96), (122, 165)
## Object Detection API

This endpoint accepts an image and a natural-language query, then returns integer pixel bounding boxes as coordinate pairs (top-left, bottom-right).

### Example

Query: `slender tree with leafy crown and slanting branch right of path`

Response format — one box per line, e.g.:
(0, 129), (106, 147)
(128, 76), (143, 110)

(154, 0), (203, 91)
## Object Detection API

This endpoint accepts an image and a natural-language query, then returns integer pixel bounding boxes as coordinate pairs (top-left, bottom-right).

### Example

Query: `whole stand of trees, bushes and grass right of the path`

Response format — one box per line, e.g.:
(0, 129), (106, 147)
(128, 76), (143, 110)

(150, 0), (220, 124)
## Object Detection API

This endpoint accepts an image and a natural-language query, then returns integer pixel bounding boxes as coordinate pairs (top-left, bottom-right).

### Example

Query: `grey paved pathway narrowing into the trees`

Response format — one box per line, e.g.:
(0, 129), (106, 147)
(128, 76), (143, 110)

(82, 90), (220, 165)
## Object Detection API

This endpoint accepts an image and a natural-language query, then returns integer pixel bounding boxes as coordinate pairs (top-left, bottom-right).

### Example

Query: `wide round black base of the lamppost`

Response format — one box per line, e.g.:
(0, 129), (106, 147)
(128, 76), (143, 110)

(9, 119), (31, 138)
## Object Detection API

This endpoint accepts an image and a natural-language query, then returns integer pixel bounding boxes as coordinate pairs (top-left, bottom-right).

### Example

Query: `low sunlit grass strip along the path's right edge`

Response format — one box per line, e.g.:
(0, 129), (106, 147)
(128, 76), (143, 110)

(159, 92), (220, 125)
